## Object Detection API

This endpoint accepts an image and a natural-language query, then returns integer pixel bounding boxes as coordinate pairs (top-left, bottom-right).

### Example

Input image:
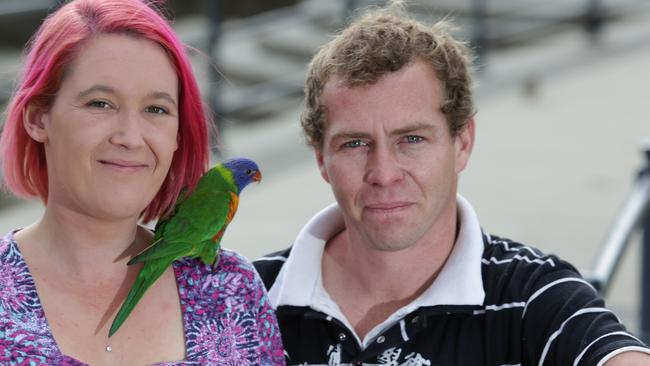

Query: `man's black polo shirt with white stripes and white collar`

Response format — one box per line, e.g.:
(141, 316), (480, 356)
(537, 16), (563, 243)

(254, 196), (650, 366)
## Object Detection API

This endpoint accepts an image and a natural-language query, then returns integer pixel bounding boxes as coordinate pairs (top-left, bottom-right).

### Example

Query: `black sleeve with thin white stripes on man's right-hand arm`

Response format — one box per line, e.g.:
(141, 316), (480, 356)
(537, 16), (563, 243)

(522, 256), (645, 365)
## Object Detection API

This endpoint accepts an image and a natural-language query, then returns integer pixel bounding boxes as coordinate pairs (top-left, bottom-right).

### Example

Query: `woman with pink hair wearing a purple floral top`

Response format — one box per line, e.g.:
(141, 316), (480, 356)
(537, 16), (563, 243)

(0, 0), (284, 365)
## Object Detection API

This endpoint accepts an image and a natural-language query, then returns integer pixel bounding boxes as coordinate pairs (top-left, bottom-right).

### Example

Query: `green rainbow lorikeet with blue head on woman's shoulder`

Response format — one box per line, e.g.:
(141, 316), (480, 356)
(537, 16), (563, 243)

(108, 158), (262, 337)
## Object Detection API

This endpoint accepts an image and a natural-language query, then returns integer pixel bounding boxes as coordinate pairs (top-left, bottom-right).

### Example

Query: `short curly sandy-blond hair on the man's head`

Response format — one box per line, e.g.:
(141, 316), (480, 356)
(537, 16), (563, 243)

(301, 1), (475, 149)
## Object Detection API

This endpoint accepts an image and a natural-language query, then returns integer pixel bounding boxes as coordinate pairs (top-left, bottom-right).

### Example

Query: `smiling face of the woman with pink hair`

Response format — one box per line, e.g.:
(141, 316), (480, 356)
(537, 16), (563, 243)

(30, 34), (179, 219)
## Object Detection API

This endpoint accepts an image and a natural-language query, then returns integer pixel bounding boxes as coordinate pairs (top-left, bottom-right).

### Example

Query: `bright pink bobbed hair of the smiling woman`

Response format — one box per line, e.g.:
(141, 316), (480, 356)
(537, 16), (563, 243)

(0, 0), (209, 221)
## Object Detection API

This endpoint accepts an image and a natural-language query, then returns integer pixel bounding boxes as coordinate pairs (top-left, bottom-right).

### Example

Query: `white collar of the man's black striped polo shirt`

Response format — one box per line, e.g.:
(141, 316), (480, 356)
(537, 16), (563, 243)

(269, 195), (485, 310)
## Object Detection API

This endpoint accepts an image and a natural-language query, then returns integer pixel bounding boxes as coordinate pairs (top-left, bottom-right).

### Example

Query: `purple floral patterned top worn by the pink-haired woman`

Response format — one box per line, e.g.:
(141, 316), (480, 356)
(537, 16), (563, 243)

(0, 232), (285, 366)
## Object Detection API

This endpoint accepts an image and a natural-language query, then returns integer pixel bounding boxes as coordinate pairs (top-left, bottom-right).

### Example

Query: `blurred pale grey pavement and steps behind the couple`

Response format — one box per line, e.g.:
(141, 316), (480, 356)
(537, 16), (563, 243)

(0, 0), (650, 331)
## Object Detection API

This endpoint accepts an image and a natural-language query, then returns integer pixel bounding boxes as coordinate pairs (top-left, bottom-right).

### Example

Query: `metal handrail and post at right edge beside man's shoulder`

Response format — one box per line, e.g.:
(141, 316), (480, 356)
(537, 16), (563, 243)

(587, 141), (650, 344)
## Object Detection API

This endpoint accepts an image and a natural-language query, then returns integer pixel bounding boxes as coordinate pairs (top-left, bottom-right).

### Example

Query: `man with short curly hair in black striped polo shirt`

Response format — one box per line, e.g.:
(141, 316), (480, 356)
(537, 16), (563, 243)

(255, 2), (650, 366)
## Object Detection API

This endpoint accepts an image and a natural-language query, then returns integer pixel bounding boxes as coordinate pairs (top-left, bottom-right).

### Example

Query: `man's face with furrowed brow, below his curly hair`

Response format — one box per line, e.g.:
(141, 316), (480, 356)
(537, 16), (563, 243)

(316, 60), (474, 251)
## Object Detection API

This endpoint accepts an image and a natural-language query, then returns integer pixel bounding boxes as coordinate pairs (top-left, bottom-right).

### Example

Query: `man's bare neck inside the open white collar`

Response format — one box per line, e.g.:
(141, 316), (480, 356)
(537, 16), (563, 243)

(322, 225), (456, 339)
